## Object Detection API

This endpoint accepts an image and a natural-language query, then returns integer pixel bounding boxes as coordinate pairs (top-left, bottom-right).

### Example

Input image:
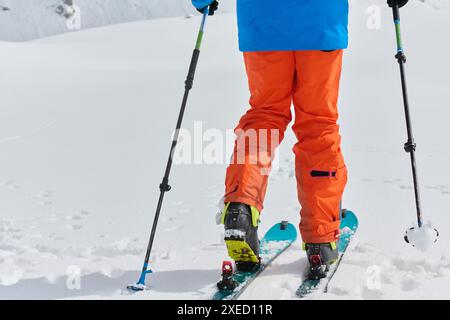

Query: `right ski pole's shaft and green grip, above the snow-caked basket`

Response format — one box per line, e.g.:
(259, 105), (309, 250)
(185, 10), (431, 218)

(392, 0), (423, 227)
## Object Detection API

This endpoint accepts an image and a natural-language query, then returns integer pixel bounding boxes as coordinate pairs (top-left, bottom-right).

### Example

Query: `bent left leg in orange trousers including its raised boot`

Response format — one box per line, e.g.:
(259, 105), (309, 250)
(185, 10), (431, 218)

(222, 52), (295, 270)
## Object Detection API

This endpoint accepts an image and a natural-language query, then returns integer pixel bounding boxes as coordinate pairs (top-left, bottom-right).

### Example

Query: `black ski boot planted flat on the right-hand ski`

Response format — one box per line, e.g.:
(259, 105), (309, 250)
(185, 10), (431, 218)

(304, 242), (339, 280)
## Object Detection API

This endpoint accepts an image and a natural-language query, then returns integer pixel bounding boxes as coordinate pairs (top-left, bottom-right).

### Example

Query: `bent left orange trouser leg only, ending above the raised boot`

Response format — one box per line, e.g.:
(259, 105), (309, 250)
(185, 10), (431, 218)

(225, 51), (295, 211)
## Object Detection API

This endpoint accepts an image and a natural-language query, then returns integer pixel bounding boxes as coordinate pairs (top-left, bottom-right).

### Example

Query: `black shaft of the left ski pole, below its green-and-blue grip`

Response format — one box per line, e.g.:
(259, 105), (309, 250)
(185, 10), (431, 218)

(142, 49), (200, 272)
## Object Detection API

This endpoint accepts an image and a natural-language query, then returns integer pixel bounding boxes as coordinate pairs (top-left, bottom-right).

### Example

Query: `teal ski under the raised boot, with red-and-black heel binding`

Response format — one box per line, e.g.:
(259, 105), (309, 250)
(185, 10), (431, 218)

(212, 221), (297, 300)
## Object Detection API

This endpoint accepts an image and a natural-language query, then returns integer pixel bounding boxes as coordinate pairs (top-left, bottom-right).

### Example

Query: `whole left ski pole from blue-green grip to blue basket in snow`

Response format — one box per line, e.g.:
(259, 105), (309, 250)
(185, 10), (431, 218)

(127, 8), (209, 291)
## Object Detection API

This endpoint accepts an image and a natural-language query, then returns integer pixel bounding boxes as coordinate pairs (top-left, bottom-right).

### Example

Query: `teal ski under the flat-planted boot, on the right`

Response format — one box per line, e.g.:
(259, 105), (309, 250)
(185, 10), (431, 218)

(296, 210), (358, 298)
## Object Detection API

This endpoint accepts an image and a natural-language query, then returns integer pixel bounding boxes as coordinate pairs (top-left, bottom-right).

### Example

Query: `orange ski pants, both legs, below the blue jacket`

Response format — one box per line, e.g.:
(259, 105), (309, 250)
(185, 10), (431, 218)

(225, 50), (347, 243)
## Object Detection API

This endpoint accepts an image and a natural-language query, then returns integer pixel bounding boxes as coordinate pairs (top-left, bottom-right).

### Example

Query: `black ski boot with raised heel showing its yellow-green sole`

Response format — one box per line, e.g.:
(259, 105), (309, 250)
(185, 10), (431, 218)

(222, 202), (261, 272)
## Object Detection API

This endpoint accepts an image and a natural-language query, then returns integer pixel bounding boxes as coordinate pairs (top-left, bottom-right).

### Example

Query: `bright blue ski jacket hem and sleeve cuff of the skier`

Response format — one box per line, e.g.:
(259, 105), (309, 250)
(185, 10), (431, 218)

(192, 0), (348, 51)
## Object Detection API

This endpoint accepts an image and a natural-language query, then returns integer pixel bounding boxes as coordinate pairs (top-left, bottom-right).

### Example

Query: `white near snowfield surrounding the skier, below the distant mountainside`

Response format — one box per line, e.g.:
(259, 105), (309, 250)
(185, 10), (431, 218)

(0, 0), (450, 299)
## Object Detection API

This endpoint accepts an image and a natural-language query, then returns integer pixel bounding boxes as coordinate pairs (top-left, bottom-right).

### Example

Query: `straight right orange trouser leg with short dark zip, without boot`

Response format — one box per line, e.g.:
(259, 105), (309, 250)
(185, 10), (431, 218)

(293, 50), (347, 247)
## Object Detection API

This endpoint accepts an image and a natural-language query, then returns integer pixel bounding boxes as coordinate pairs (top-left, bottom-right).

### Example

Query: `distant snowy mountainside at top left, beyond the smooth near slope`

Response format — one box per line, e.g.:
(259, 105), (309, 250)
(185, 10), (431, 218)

(0, 0), (234, 41)
